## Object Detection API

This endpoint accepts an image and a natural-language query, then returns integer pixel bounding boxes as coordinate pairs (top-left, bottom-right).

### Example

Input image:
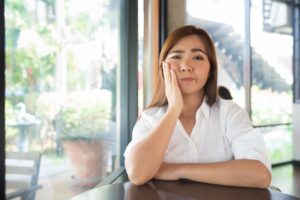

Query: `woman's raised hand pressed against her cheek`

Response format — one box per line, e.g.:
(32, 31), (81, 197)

(163, 62), (183, 116)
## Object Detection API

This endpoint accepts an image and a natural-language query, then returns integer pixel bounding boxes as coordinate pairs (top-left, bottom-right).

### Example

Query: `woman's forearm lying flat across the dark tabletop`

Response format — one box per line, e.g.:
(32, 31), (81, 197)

(178, 159), (271, 188)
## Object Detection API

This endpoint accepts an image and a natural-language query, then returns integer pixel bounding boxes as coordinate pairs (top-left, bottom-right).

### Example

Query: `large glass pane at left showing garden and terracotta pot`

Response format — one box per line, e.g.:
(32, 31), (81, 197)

(5, 0), (120, 199)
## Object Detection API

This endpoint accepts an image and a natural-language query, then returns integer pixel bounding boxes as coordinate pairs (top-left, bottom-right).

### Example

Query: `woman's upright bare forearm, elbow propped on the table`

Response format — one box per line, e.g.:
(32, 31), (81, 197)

(125, 110), (178, 185)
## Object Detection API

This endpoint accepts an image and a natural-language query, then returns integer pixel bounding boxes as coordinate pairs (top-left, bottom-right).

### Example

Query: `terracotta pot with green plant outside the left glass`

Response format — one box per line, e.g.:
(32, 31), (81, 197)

(60, 90), (115, 187)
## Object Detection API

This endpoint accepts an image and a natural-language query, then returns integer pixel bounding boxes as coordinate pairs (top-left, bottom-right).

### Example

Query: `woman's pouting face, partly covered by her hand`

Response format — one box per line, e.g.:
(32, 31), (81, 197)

(165, 35), (210, 95)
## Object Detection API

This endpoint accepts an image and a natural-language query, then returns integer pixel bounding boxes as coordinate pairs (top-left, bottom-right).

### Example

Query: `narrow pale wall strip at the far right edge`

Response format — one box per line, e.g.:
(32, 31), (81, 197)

(293, 104), (300, 161)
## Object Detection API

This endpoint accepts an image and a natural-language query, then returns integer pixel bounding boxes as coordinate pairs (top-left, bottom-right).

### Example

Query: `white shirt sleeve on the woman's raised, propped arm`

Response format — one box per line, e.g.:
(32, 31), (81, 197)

(124, 111), (153, 157)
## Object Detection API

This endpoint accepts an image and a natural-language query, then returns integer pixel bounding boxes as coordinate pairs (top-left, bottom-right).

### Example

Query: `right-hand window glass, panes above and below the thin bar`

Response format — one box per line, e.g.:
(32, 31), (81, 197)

(251, 0), (293, 163)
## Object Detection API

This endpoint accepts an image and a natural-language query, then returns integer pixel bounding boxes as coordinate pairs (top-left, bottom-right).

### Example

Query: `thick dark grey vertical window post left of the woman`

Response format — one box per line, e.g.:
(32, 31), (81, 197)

(117, 0), (138, 167)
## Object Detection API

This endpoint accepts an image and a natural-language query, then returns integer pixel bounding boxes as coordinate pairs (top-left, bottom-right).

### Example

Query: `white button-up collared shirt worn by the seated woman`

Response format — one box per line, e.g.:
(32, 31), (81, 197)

(124, 98), (271, 171)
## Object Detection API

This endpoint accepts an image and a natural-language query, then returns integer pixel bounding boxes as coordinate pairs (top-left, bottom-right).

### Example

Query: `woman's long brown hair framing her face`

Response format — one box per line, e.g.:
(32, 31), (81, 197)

(147, 26), (218, 108)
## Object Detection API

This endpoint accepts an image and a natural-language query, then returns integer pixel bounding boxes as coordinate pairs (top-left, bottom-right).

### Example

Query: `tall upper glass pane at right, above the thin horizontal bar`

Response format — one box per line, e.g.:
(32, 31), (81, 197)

(251, 0), (293, 125)
